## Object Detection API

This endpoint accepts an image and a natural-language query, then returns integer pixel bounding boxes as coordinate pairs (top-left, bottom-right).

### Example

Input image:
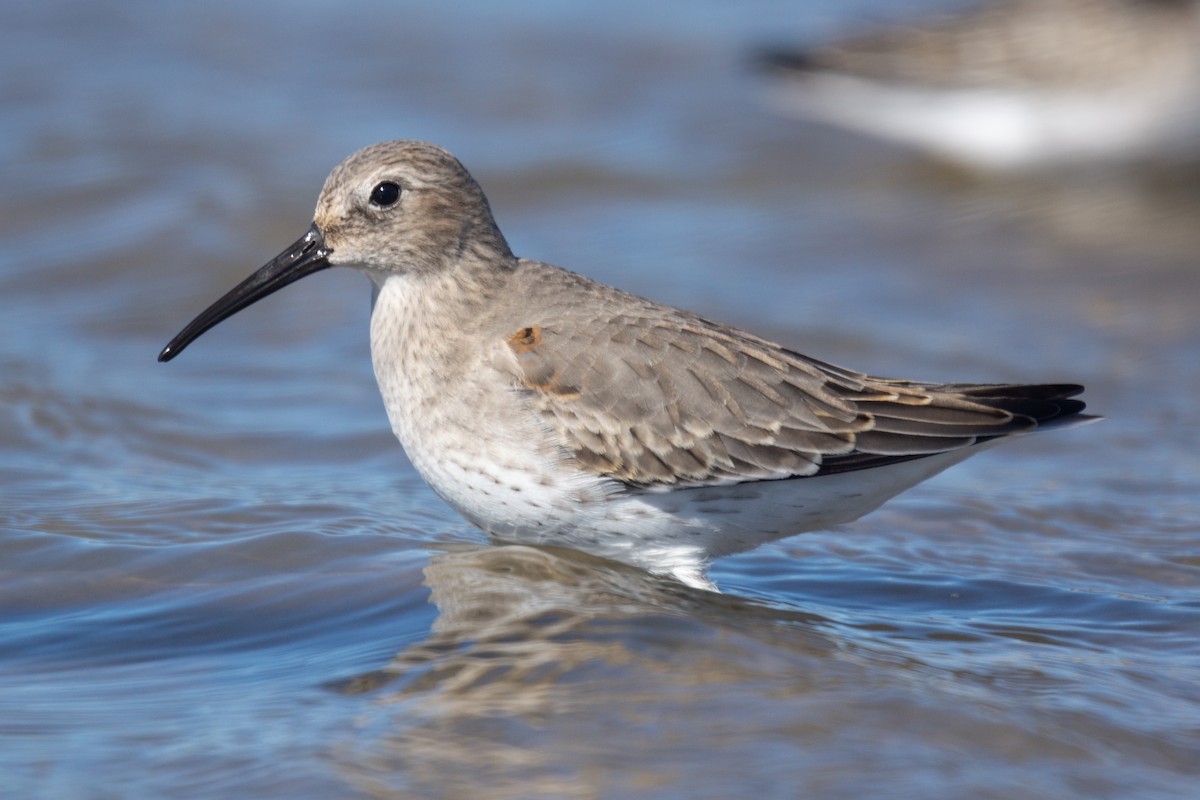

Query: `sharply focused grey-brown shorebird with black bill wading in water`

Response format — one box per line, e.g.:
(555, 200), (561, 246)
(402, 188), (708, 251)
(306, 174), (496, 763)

(158, 142), (1091, 588)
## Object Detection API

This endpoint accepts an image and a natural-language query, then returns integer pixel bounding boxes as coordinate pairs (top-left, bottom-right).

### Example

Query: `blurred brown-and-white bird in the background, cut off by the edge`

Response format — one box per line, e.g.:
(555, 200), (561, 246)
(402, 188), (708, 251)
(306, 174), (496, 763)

(758, 0), (1200, 170)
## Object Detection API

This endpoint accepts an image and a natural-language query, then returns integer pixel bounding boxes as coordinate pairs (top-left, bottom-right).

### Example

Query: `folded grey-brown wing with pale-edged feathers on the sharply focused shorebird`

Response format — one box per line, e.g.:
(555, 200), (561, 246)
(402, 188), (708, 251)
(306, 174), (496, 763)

(492, 303), (1082, 488)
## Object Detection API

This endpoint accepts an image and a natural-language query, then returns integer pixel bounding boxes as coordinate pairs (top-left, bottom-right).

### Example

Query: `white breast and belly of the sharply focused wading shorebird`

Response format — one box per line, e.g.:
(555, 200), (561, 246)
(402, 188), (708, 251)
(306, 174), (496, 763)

(371, 275), (998, 587)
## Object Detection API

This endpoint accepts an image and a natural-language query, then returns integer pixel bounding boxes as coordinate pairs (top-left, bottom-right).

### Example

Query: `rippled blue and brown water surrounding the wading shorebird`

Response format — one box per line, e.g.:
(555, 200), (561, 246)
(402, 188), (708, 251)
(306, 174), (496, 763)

(0, 0), (1200, 798)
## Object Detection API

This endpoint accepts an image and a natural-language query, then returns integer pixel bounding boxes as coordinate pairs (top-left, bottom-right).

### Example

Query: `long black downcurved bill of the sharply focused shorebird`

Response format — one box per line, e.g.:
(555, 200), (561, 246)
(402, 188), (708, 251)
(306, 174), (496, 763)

(158, 222), (332, 361)
